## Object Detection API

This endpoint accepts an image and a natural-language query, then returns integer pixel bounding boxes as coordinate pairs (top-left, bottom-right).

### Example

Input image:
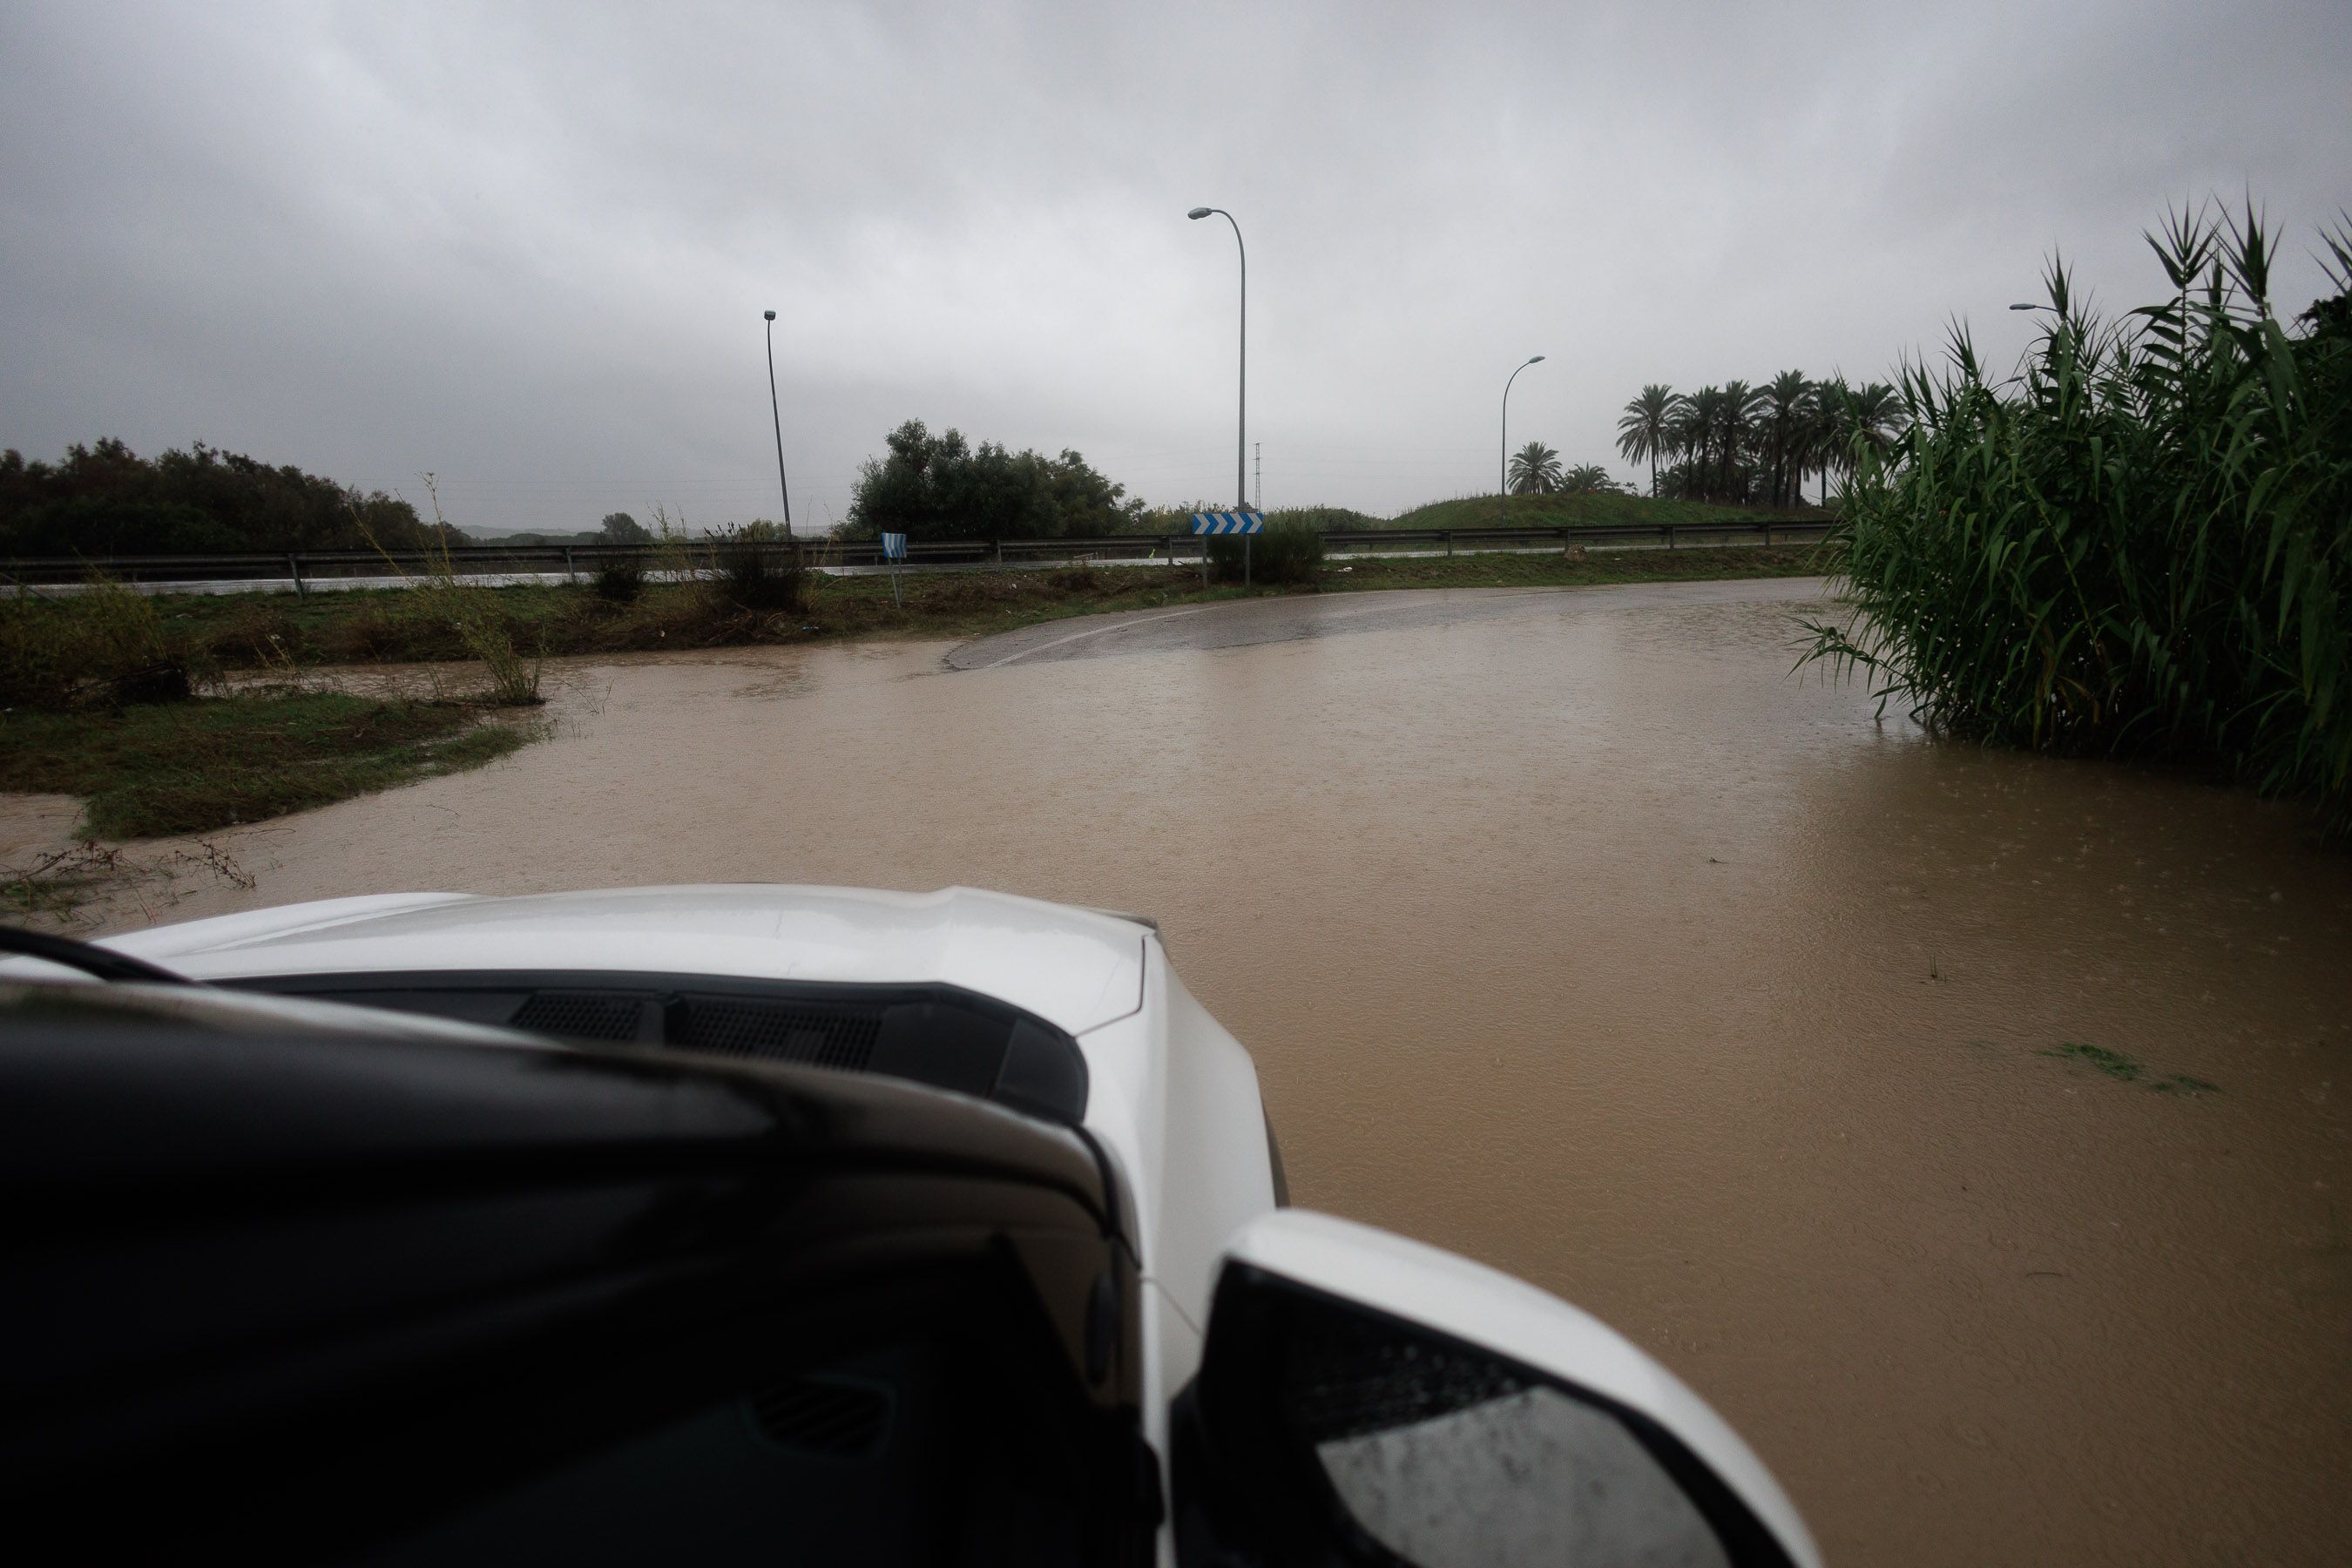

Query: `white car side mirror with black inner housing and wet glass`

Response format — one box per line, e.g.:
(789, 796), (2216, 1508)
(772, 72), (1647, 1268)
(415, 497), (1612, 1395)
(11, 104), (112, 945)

(1172, 1208), (1821, 1568)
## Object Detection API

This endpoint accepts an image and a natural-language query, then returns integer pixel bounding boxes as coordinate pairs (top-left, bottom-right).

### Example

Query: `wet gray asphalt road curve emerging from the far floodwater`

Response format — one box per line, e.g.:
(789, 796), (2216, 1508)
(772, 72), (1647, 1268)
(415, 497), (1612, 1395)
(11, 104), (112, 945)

(948, 576), (1823, 670)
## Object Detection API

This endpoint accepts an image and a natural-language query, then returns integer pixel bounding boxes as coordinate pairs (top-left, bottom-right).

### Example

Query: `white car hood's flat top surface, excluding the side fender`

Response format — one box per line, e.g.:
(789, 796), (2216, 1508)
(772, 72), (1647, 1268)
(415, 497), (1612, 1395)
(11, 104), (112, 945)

(106, 884), (1148, 1034)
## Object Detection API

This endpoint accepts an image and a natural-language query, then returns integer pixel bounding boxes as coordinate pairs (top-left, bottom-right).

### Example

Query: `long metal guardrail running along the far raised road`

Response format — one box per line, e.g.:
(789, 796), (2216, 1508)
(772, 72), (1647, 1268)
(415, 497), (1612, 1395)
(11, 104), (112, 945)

(0, 517), (1832, 592)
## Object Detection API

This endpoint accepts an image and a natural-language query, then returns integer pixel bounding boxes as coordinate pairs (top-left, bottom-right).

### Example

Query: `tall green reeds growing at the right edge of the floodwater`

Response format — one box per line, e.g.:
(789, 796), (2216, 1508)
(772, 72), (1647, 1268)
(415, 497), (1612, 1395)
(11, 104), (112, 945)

(1808, 212), (2352, 832)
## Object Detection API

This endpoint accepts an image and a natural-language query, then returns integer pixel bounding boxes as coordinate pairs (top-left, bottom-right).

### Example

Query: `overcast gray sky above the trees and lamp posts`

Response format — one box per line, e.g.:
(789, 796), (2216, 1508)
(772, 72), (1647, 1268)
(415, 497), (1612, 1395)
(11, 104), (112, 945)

(0, 0), (2352, 529)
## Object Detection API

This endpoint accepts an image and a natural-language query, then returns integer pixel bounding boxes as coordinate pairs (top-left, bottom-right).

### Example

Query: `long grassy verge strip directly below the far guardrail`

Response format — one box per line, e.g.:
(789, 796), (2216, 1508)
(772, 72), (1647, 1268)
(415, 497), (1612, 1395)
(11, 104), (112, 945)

(114, 545), (1825, 670)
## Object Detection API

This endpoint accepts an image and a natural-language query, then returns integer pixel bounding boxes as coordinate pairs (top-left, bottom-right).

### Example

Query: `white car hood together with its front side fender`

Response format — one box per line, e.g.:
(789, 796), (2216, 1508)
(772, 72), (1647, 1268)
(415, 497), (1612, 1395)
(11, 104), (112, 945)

(91, 884), (1274, 1453)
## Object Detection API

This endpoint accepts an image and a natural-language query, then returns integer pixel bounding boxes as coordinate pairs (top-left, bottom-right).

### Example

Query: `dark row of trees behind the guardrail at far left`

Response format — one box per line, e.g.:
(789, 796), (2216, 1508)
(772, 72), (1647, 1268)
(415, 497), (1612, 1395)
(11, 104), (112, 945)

(0, 437), (442, 558)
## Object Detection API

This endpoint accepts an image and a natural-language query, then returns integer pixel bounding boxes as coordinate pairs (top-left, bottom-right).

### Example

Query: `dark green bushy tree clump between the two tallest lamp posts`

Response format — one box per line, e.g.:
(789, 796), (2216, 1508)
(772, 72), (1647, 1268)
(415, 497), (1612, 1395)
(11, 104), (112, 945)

(842, 418), (1143, 538)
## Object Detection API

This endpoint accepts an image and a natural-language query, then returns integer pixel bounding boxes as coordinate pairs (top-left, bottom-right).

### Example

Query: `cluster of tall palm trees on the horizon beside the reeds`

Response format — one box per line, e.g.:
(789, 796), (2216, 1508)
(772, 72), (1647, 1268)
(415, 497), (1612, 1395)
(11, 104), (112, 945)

(1619, 371), (1905, 505)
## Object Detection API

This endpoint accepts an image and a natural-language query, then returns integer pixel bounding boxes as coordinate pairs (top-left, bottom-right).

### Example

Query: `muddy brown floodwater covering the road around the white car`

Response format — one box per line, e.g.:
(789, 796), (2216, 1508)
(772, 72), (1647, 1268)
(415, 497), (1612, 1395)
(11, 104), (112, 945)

(23, 583), (2352, 1564)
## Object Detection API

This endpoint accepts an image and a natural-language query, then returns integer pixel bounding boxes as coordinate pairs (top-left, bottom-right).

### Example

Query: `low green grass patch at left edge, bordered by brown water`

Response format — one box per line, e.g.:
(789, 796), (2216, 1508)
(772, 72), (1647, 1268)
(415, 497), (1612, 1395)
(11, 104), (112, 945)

(0, 691), (537, 839)
